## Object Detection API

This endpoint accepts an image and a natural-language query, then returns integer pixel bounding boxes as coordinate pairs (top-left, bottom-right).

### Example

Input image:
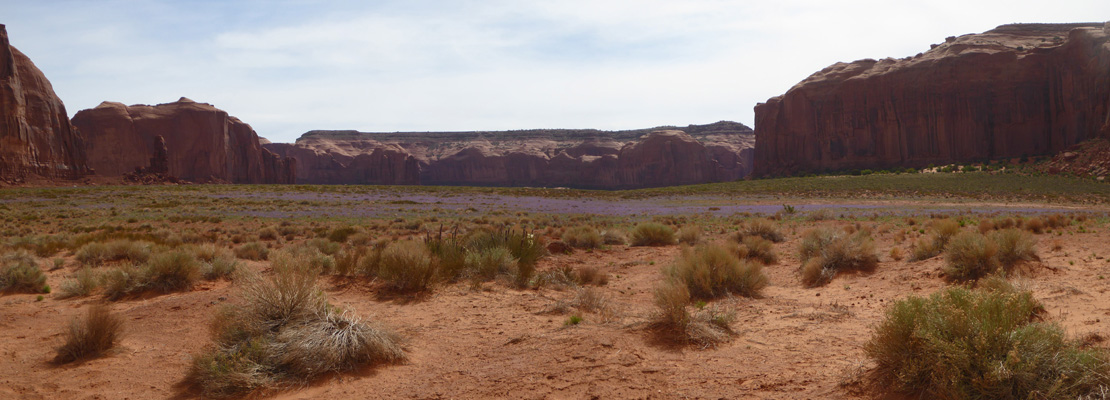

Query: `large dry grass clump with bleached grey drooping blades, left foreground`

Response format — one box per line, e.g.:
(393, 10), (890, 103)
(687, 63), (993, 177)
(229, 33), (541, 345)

(188, 268), (405, 397)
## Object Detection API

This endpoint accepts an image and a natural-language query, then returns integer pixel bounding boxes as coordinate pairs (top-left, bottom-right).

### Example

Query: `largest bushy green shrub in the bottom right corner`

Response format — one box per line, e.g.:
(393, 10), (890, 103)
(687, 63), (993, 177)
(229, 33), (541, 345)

(865, 278), (1110, 399)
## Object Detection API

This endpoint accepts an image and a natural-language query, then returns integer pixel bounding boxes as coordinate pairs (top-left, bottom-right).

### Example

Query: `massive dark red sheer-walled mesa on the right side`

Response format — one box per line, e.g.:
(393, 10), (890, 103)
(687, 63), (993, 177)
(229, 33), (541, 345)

(754, 23), (1110, 176)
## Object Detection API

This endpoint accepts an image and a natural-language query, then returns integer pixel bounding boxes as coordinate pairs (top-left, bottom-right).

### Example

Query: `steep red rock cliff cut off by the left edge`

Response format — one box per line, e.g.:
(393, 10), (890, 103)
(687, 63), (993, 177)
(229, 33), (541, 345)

(0, 24), (90, 182)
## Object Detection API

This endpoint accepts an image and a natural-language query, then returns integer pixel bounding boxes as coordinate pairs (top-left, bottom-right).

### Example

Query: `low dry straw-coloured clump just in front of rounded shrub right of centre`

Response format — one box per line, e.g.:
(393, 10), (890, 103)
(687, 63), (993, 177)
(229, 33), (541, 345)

(652, 280), (736, 349)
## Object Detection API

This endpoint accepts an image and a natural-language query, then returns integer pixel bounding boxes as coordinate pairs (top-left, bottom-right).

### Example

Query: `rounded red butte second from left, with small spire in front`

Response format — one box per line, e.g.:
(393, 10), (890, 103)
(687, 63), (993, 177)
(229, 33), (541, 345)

(73, 98), (295, 183)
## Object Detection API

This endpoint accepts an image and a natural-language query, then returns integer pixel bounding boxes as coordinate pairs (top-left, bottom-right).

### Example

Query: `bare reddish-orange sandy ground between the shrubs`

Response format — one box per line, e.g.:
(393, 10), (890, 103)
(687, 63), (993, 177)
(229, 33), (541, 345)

(0, 185), (1110, 399)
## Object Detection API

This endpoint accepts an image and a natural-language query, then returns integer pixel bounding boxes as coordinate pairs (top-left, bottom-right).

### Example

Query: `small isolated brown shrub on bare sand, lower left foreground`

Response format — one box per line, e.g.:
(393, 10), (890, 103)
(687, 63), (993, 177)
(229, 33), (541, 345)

(54, 304), (123, 363)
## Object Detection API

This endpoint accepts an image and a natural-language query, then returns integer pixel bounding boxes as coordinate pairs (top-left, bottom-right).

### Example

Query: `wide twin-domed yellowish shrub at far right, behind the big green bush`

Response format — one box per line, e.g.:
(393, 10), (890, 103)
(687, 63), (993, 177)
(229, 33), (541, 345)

(945, 229), (1040, 282)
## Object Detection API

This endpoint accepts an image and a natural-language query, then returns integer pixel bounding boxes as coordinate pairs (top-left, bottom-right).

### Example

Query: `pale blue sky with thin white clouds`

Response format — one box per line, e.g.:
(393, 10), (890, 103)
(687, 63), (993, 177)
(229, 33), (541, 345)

(0, 0), (1110, 142)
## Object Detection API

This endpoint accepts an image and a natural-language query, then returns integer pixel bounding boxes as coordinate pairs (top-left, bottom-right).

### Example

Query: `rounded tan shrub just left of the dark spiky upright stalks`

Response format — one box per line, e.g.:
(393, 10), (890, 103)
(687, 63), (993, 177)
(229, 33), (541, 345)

(377, 240), (436, 291)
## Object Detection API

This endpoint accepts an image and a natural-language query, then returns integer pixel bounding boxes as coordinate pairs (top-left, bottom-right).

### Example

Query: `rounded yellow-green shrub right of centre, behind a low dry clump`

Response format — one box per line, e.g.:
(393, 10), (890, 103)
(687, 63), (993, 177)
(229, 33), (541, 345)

(666, 244), (767, 299)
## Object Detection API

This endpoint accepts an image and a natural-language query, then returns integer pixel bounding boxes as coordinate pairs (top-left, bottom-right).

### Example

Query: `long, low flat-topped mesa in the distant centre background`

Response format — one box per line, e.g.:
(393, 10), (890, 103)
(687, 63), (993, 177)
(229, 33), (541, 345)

(265, 121), (754, 189)
